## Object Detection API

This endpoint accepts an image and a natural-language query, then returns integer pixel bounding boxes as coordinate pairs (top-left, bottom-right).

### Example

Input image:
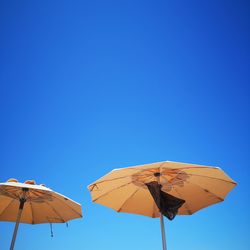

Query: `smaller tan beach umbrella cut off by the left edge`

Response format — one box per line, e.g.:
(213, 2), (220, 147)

(0, 179), (82, 250)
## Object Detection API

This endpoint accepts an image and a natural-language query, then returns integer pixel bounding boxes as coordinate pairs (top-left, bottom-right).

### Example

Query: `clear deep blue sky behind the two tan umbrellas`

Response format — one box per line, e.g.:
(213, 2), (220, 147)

(0, 0), (250, 250)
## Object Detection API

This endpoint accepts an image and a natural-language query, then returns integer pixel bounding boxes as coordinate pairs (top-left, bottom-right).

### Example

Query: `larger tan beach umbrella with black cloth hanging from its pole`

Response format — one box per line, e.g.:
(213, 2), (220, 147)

(88, 161), (236, 250)
